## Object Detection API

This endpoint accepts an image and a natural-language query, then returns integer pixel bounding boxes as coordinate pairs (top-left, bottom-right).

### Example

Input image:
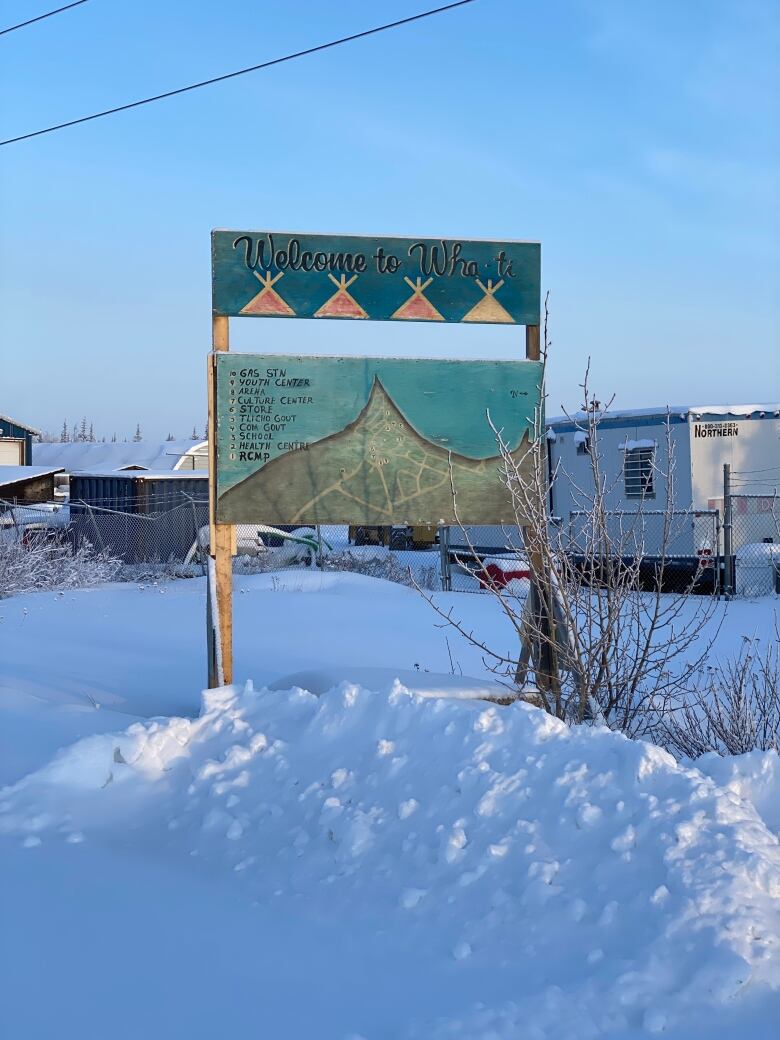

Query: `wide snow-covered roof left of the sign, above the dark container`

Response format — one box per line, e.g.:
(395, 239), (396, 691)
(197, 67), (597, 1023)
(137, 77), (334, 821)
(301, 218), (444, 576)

(32, 440), (206, 473)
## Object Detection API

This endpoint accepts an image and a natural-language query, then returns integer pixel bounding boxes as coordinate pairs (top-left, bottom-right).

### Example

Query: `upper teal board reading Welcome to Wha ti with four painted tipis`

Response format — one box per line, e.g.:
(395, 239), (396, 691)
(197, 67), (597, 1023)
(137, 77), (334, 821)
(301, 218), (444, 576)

(211, 231), (541, 326)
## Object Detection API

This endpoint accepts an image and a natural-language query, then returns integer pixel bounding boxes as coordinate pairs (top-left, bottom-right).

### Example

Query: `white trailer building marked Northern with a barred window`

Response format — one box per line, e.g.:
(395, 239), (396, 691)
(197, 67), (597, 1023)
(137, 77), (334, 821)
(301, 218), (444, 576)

(546, 404), (780, 578)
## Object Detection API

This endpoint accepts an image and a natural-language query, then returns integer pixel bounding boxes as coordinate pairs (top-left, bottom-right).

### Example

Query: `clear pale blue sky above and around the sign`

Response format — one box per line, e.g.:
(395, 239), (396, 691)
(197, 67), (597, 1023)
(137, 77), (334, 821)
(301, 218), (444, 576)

(0, 0), (780, 438)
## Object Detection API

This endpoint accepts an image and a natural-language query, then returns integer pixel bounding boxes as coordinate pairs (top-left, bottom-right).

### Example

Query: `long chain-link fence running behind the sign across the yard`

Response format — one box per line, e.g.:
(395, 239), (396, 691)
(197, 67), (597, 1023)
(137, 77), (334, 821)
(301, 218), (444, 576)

(0, 493), (780, 596)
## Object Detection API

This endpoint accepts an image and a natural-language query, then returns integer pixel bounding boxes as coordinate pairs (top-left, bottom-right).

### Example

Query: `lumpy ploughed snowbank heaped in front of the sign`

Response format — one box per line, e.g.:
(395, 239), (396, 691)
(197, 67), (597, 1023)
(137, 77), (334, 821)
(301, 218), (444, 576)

(0, 683), (780, 1040)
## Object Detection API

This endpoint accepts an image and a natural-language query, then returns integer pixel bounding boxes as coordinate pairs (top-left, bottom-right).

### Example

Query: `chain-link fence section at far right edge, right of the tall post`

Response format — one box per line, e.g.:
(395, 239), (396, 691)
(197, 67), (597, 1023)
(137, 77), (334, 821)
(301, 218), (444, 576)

(726, 493), (780, 597)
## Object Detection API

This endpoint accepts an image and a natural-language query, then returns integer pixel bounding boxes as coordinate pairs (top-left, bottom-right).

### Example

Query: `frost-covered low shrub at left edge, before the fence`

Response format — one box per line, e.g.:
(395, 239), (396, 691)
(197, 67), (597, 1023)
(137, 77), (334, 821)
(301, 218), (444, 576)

(0, 535), (122, 598)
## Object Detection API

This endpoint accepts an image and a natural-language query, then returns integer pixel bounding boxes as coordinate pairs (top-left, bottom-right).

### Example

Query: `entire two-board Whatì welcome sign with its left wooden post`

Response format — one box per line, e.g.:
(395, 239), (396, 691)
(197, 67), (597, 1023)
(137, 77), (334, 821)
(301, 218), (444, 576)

(207, 231), (542, 687)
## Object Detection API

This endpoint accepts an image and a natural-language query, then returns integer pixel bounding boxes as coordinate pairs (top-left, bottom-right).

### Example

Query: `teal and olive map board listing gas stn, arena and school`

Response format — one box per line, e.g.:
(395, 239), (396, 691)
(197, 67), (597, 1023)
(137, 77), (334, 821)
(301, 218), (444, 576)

(214, 354), (542, 525)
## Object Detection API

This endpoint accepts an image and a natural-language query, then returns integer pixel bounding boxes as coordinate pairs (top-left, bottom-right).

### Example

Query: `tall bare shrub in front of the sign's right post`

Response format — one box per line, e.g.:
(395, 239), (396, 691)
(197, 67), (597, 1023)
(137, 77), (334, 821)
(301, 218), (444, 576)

(416, 303), (719, 736)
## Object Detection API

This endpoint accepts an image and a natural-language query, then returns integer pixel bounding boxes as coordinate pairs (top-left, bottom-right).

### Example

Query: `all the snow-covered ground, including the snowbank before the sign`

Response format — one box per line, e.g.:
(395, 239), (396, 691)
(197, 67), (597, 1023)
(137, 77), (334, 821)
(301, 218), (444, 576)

(0, 571), (780, 1040)
